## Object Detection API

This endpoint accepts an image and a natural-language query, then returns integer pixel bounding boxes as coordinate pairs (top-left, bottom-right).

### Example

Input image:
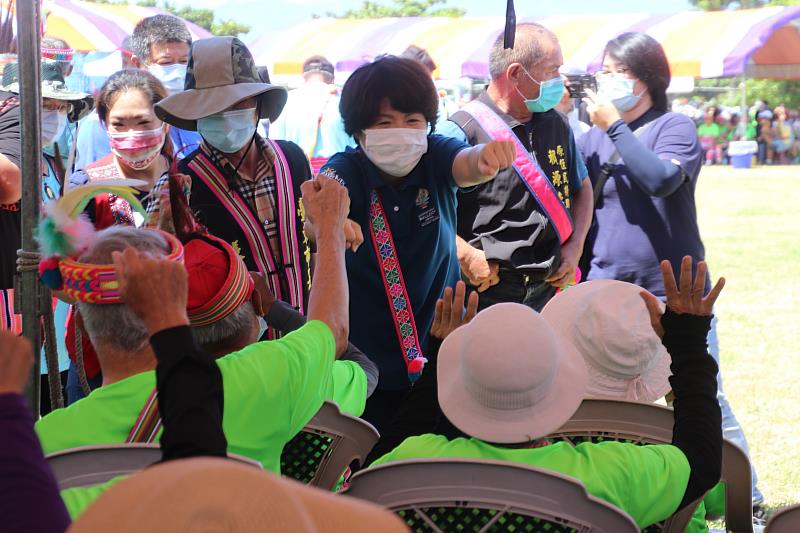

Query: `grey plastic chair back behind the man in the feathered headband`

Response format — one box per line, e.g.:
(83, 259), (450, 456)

(46, 443), (261, 490)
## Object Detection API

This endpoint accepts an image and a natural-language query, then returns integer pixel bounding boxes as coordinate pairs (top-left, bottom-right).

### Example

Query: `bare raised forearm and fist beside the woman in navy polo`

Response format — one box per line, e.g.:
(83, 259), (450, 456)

(301, 175), (350, 355)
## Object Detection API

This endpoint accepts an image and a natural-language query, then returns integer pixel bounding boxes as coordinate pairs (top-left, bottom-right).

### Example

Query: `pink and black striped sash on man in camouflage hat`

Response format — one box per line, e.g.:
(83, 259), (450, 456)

(188, 141), (305, 313)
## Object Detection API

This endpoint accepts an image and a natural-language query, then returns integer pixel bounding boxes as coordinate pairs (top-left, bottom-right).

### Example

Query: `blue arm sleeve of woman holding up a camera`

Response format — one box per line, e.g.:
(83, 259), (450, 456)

(606, 119), (684, 198)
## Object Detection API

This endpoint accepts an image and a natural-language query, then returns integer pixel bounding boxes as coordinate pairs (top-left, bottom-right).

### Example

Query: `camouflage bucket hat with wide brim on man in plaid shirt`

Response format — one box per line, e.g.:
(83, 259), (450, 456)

(155, 37), (288, 131)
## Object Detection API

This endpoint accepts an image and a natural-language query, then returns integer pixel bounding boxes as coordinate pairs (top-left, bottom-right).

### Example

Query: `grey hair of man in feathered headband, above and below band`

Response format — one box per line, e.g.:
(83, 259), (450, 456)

(76, 226), (169, 353)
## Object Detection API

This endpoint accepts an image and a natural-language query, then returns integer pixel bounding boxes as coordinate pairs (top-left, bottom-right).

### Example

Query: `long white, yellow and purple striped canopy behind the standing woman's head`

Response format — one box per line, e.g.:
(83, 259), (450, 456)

(251, 6), (800, 79)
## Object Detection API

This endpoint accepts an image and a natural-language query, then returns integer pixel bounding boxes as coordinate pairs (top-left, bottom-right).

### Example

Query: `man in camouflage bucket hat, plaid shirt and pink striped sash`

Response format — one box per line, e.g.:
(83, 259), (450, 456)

(148, 37), (311, 335)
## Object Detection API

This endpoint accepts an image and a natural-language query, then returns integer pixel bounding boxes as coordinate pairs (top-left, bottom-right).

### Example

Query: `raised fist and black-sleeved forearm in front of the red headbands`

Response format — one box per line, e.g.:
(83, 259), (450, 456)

(113, 248), (228, 461)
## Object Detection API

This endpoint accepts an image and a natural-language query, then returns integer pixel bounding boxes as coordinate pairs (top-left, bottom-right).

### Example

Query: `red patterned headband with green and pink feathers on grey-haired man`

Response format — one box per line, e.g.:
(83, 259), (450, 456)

(36, 180), (183, 304)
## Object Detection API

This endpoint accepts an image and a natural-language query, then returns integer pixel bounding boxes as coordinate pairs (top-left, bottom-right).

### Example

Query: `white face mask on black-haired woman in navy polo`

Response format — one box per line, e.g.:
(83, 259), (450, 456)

(361, 128), (428, 178)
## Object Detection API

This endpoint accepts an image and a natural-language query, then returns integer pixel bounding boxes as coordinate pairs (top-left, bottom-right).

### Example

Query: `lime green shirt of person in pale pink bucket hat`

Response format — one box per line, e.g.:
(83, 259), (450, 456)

(372, 435), (689, 528)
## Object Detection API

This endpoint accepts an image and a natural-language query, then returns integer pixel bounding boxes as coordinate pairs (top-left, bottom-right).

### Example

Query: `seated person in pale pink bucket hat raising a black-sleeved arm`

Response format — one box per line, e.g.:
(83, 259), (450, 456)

(373, 257), (724, 528)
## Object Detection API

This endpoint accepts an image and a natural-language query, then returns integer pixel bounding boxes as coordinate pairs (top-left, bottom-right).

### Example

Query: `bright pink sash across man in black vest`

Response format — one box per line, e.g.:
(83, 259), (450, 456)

(461, 100), (573, 244)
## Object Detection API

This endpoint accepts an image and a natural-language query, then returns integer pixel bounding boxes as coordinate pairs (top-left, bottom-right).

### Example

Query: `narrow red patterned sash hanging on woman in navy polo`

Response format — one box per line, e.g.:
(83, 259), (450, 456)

(369, 190), (428, 383)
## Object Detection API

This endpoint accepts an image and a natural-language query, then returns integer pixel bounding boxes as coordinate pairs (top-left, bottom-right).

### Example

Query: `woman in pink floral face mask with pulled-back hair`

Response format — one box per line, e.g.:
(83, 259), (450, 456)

(70, 69), (172, 224)
